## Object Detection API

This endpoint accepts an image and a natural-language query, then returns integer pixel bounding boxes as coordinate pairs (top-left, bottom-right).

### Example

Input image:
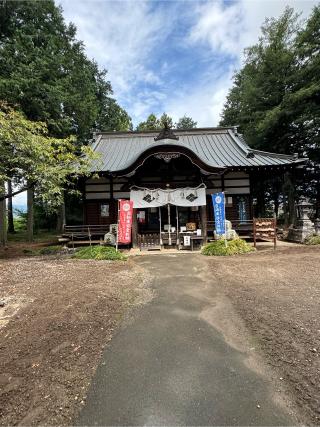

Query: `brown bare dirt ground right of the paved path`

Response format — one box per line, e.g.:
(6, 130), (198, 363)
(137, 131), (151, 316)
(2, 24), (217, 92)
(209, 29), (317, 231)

(208, 246), (320, 425)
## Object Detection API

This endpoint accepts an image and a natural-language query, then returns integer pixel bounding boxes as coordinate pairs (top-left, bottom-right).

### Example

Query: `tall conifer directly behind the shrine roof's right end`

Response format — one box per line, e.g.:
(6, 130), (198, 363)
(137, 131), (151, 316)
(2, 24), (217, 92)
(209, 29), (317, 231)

(220, 8), (299, 153)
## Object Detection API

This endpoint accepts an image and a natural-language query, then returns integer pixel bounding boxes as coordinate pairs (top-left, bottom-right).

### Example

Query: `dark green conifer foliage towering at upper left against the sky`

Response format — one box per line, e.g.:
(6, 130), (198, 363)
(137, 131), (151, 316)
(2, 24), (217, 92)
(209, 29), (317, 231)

(0, 0), (131, 144)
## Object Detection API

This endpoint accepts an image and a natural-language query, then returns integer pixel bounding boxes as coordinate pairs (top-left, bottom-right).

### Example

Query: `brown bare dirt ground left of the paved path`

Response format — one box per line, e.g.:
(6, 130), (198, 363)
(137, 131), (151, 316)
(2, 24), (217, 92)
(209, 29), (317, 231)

(0, 256), (151, 425)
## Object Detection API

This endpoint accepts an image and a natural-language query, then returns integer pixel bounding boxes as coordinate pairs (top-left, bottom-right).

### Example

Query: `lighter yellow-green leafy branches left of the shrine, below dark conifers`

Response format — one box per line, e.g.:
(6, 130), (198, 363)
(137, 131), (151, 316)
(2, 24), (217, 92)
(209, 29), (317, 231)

(0, 104), (94, 209)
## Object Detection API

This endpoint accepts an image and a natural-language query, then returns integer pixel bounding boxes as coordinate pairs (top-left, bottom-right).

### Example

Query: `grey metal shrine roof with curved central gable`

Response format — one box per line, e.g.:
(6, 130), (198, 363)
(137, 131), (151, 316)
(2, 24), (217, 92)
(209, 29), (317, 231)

(92, 128), (304, 173)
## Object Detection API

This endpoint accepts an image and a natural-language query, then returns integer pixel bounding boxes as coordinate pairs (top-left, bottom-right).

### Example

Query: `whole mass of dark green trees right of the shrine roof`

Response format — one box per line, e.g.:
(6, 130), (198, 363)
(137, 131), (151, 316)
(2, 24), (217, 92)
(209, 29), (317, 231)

(220, 5), (320, 214)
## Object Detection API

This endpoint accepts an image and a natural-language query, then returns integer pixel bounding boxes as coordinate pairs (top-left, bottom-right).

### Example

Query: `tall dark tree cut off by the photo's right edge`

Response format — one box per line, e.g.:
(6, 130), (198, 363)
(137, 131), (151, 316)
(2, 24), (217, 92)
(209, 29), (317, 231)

(288, 5), (320, 213)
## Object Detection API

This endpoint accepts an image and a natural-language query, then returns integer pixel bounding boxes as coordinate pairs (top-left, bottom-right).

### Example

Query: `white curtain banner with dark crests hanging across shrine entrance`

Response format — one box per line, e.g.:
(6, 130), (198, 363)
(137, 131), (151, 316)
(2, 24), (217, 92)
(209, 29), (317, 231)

(130, 185), (207, 209)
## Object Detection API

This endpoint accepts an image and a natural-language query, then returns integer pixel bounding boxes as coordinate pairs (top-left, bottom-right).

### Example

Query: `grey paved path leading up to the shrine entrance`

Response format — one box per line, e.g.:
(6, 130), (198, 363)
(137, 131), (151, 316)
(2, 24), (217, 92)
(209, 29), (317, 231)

(77, 254), (295, 426)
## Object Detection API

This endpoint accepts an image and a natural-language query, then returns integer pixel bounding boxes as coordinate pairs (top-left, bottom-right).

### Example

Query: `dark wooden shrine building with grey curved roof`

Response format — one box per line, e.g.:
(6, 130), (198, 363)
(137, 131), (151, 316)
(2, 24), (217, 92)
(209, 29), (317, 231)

(65, 127), (304, 246)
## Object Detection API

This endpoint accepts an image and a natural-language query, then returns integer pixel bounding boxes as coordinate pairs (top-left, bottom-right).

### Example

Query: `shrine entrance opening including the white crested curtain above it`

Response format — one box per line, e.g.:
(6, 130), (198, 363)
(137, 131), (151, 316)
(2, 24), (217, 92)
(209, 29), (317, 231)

(131, 184), (206, 250)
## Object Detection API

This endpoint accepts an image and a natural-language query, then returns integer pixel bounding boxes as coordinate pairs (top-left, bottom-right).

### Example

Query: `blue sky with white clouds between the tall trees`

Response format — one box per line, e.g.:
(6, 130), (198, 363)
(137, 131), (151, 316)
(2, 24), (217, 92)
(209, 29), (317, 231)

(15, 0), (317, 207)
